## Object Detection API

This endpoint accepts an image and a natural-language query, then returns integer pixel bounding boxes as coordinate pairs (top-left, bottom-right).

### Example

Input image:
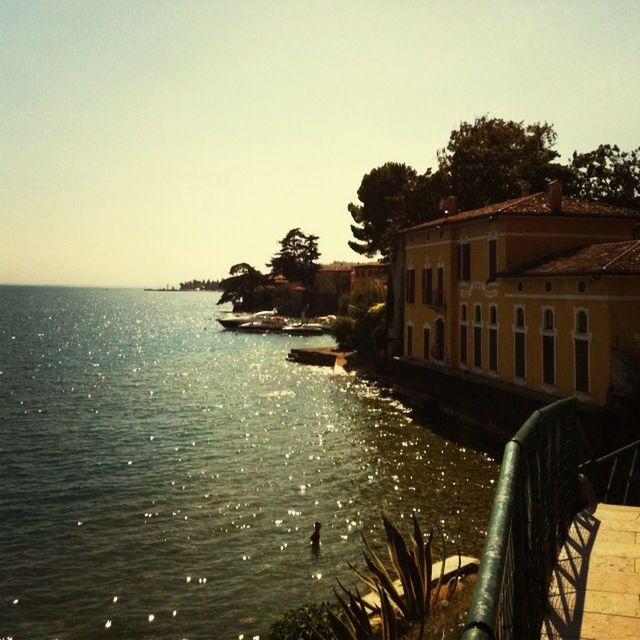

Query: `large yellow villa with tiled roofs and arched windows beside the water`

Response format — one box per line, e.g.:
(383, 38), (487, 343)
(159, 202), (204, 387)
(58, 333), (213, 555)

(402, 182), (640, 405)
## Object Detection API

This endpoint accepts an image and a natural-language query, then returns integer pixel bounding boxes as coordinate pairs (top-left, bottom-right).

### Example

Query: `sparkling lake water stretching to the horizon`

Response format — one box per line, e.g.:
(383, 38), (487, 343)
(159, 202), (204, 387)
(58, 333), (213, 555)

(0, 287), (497, 640)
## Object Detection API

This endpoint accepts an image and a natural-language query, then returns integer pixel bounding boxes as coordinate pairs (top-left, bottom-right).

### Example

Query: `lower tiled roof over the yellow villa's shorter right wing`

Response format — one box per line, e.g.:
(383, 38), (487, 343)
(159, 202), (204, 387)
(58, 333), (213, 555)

(498, 240), (640, 277)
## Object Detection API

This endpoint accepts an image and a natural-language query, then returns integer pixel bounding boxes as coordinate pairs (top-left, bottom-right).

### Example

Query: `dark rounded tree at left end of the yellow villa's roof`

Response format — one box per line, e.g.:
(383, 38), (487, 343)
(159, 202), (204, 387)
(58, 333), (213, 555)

(347, 162), (439, 260)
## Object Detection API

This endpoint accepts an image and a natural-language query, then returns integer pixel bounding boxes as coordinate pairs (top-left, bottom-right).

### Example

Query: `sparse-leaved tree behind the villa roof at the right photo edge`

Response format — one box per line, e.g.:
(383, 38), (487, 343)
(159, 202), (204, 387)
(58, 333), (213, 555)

(568, 144), (640, 208)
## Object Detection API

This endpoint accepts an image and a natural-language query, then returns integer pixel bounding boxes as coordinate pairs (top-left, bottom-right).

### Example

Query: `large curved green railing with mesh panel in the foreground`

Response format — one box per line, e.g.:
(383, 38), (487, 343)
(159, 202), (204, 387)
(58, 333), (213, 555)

(462, 398), (584, 640)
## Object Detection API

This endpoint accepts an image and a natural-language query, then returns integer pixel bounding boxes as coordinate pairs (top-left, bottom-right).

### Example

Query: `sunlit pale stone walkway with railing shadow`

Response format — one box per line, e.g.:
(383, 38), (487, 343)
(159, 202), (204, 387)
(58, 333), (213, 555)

(541, 504), (640, 640)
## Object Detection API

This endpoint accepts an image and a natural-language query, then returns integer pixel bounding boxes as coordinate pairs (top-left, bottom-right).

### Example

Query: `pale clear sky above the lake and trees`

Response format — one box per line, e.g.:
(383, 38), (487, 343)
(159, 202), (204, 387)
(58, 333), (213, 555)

(0, 0), (640, 287)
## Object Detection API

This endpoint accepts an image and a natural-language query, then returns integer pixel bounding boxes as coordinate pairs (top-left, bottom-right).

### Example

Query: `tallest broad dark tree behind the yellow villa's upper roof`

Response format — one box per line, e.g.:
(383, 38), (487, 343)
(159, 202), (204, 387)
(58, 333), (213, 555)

(436, 116), (567, 210)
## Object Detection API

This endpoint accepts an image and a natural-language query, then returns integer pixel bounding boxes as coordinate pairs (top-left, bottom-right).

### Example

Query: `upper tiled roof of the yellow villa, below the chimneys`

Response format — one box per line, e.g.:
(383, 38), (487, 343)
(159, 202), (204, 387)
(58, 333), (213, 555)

(401, 192), (640, 233)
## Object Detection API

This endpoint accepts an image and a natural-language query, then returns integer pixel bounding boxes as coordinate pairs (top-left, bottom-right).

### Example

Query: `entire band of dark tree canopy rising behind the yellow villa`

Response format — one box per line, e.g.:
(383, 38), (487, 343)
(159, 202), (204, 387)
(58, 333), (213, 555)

(347, 116), (640, 260)
